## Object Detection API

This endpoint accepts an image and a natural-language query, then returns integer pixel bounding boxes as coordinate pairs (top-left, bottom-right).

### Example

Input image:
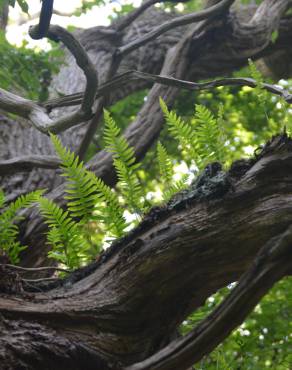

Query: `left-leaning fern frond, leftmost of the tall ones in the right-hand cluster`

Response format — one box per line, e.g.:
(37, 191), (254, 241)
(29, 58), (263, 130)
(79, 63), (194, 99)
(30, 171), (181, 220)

(160, 98), (196, 158)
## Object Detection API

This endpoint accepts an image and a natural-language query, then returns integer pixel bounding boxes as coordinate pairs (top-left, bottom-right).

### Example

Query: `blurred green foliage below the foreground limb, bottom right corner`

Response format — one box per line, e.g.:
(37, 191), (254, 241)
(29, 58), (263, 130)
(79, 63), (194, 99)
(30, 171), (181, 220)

(181, 278), (292, 370)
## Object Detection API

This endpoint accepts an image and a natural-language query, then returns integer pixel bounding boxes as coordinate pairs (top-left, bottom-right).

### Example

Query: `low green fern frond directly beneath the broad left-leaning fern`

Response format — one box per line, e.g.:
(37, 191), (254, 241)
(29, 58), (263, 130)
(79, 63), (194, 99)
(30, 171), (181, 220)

(39, 198), (90, 269)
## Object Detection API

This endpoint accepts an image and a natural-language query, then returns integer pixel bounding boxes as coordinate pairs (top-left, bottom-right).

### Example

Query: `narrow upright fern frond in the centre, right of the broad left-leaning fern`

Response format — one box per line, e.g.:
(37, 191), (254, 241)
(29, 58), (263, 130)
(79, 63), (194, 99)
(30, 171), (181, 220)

(104, 110), (143, 213)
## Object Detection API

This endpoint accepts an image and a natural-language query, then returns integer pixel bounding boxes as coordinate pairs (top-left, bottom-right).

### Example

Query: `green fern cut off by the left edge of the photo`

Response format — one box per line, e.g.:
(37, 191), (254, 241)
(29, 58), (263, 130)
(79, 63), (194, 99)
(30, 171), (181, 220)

(0, 190), (44, 263)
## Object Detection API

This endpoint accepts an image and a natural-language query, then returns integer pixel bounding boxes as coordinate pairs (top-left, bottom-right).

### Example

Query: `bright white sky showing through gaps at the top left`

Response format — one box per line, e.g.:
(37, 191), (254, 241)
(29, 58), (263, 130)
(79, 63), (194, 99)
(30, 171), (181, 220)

(7, 0), (140, 48)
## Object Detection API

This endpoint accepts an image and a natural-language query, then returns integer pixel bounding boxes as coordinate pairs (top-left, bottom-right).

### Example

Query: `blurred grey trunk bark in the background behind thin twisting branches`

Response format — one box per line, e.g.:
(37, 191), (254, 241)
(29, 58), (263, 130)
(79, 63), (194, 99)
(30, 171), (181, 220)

(0, 0), (292, 266)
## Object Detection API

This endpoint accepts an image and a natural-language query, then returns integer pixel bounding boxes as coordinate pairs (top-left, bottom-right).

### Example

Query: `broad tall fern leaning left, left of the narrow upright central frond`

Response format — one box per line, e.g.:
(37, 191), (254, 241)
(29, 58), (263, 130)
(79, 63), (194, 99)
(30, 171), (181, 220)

(51, 134), (127, 237)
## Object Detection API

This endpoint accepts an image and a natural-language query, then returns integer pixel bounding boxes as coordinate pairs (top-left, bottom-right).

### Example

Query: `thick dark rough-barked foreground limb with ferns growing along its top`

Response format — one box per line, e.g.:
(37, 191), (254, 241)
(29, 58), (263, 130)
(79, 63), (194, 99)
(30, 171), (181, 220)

(0, 135), (292, 370)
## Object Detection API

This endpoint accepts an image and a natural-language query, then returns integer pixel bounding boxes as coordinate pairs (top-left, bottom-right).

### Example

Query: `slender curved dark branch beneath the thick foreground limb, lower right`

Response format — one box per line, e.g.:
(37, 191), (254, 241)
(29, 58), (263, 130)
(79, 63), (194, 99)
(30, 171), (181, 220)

(125, 226), (292, 370)
